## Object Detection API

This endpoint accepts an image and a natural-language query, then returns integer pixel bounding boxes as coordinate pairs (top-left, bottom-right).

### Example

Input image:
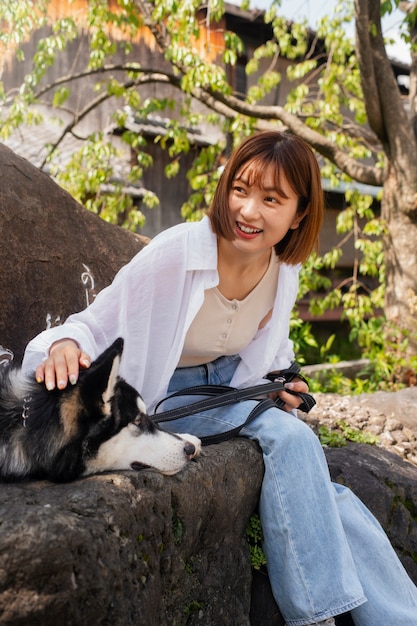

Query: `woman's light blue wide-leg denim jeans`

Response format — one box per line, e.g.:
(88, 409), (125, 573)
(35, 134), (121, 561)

(160, 357), (417, 626)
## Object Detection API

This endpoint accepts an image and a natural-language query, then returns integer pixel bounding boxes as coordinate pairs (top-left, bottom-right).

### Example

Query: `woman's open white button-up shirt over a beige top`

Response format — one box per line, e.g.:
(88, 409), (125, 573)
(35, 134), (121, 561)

(23, 217), (299, 411)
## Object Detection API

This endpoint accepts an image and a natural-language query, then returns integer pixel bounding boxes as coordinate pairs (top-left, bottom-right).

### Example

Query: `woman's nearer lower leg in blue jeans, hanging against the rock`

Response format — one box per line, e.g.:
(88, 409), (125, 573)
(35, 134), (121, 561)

(247, 409), (364, 626)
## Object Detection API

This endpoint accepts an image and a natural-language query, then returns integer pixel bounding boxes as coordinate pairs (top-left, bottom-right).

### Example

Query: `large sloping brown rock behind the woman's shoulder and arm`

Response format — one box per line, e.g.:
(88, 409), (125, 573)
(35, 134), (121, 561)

(0, 144), (147, 360)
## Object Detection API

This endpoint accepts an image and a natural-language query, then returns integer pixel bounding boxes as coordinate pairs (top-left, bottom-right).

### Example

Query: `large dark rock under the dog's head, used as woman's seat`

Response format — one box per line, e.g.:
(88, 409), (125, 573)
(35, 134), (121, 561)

(0, 440), (263, 626)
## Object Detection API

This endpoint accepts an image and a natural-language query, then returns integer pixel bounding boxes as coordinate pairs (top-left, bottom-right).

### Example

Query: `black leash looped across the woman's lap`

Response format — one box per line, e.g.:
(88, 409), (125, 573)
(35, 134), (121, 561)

(152, 362), (316, 446)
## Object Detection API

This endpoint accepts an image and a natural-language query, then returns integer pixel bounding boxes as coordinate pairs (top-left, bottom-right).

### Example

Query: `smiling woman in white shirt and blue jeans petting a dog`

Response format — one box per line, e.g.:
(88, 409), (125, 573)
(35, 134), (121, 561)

(24, 131), (417, 626)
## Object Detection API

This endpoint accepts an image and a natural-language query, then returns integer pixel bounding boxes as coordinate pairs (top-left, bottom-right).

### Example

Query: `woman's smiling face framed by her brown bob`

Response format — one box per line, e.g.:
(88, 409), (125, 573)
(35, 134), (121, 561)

(229, 163), (304, 252)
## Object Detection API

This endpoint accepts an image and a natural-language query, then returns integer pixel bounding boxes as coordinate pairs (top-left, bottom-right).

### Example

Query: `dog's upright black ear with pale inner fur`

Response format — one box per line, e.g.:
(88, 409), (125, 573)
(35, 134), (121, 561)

(80, 338), (124, 415)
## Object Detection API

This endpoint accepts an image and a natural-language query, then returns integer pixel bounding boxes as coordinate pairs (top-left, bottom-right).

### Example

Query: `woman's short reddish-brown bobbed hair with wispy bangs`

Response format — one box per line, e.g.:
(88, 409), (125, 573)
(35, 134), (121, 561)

(208, 130), (324, 265)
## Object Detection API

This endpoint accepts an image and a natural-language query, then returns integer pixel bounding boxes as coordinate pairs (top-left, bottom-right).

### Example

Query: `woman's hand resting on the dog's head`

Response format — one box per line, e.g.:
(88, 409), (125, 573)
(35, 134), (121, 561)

(35, 339), (91, 391)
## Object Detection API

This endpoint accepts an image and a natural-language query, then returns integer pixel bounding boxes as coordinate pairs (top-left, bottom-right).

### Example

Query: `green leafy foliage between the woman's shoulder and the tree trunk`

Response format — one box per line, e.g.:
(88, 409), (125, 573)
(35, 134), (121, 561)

(299, 178), (417, 394)
